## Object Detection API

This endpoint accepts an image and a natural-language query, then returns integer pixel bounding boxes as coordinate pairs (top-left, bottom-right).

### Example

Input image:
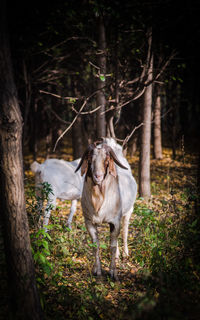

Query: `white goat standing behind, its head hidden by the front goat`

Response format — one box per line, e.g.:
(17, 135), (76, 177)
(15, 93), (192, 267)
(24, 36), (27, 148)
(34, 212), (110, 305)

(31, 159), (83, 228)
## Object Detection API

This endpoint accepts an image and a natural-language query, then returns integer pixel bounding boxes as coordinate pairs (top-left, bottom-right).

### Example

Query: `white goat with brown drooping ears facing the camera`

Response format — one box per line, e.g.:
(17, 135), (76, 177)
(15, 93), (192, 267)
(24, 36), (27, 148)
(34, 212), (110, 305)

(76, 138), (137, 279)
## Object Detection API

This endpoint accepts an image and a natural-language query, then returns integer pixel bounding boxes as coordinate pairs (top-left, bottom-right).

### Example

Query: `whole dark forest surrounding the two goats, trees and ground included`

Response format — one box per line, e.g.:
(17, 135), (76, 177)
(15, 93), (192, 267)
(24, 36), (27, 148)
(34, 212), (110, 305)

(0, 0), (200, 320)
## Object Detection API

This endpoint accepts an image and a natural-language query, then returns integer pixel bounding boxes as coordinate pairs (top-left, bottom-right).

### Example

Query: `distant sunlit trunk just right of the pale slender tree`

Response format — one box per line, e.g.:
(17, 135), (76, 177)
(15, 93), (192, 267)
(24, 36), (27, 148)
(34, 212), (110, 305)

(154, 84), (163, 160)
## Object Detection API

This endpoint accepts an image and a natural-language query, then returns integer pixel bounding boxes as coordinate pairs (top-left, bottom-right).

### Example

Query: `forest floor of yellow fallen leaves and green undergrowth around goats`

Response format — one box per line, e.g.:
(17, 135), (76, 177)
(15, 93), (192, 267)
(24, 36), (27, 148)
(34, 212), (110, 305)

(0, 149), (200, 320)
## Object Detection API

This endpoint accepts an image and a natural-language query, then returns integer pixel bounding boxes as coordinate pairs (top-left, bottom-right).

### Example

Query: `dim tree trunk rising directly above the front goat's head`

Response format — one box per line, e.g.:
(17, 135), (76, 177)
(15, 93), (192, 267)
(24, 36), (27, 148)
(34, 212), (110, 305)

(96, 16), (106, 138)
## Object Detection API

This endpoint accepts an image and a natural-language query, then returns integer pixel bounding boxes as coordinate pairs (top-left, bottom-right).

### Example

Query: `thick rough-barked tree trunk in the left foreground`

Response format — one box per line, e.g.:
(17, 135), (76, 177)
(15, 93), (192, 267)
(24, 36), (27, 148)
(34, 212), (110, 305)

(0, 1), (42, 320)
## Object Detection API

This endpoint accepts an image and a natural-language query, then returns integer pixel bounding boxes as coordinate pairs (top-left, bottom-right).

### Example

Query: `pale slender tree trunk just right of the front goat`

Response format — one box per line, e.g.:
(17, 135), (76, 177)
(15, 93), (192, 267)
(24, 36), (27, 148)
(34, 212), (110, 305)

(139, 29), (153, 199)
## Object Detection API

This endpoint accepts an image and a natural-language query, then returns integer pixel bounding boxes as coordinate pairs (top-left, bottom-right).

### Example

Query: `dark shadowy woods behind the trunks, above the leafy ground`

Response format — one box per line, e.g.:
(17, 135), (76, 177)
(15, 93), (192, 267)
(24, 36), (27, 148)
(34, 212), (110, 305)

(8, 1), (200, 157)
